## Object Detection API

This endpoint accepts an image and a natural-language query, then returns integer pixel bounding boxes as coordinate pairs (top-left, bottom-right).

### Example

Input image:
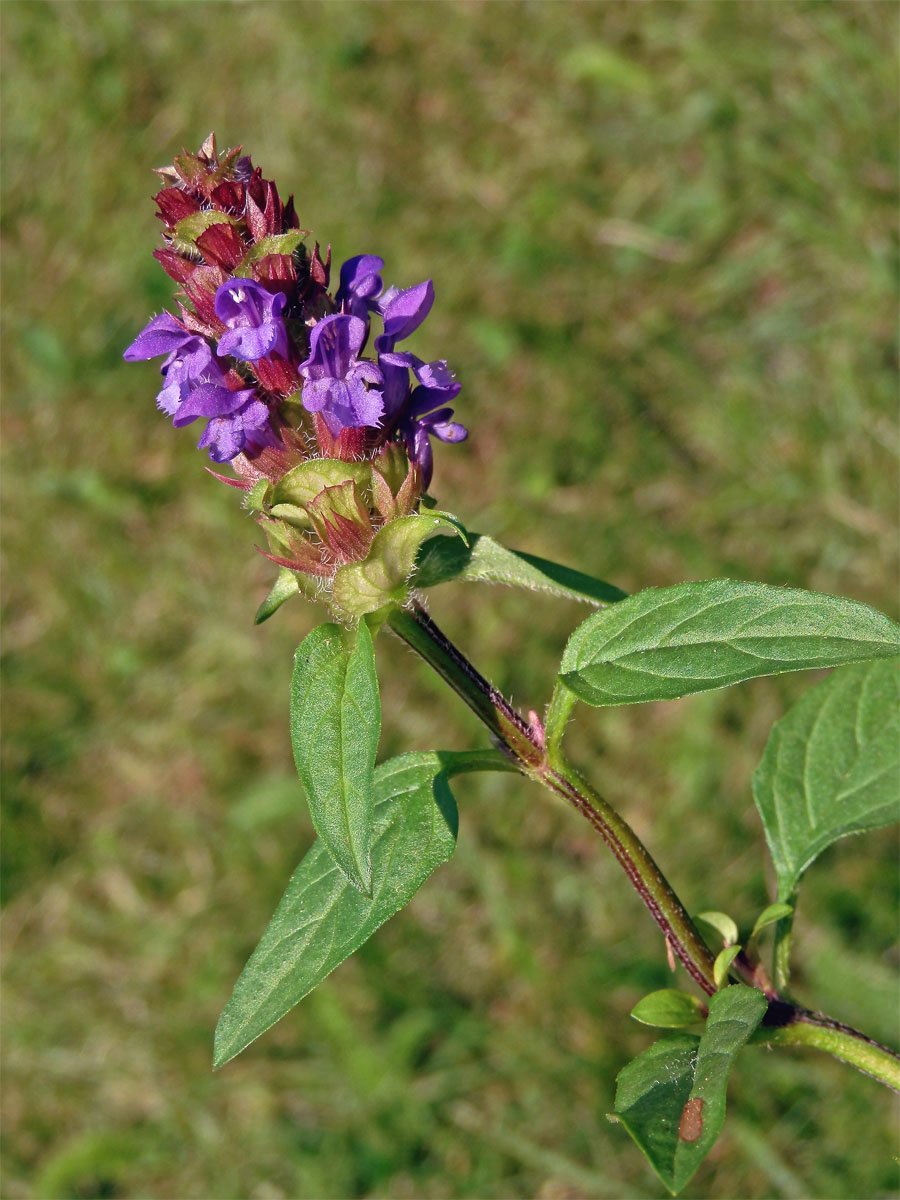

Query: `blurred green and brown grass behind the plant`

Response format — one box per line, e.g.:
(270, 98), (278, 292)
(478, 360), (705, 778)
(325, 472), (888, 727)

(2, 0), (898, 1200)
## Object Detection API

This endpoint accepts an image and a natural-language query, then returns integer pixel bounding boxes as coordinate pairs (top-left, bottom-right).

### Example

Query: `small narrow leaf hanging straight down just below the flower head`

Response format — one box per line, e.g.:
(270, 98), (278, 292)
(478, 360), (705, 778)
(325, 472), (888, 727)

(290, 624), (382, 895)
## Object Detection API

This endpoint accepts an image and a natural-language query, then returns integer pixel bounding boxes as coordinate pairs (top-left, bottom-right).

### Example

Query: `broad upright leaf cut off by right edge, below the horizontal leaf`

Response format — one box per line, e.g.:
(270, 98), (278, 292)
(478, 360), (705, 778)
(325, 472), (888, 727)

(754, 661), (900, 900)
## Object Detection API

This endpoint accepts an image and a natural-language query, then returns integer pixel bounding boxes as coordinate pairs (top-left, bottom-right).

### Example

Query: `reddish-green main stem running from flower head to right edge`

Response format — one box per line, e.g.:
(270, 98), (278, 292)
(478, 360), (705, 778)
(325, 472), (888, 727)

(388, 604), (900, 1091)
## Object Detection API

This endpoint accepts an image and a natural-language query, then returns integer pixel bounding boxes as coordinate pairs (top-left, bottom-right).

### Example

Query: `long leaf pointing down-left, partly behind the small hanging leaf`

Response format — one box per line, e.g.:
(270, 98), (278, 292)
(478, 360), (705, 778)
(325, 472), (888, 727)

(214, 750), (510, 1067)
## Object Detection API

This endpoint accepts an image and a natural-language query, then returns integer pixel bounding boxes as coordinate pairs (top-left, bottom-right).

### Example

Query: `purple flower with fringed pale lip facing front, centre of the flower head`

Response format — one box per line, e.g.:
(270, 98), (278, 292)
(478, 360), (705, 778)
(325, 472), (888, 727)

(299, 313), (384, 437)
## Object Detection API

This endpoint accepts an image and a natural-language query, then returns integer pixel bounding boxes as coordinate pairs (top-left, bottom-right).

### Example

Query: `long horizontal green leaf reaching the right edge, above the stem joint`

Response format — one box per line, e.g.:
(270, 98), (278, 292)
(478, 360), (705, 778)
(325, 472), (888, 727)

(559, 580), (900, 704)
